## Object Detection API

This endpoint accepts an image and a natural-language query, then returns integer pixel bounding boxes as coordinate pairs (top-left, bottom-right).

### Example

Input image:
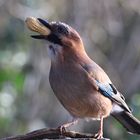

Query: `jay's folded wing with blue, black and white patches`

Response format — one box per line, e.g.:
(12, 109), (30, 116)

(82, 65), (131, 112)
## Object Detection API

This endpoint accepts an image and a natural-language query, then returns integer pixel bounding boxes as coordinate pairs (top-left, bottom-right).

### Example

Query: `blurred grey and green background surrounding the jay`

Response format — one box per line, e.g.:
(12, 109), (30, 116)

(0, 0), (140, 140)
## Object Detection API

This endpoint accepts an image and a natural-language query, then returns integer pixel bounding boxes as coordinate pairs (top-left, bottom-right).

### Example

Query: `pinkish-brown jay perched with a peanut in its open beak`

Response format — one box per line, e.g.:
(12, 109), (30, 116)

(26, 17), (140, 139)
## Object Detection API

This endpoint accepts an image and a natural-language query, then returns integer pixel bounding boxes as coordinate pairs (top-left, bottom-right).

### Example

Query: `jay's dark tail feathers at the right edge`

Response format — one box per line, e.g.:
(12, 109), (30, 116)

(112, 111), (140, 135)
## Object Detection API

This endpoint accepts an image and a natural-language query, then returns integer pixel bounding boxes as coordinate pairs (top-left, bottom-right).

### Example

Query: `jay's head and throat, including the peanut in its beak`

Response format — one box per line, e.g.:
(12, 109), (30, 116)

(26, 17), (85, 61)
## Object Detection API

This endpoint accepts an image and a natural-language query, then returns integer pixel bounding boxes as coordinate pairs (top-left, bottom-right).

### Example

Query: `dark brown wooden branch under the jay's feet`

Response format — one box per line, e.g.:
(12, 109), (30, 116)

(0, 128), (109, 140)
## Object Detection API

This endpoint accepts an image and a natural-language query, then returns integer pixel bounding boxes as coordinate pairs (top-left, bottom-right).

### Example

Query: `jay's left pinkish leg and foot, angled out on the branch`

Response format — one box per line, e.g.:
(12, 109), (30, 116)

(58, 118), (78, 134)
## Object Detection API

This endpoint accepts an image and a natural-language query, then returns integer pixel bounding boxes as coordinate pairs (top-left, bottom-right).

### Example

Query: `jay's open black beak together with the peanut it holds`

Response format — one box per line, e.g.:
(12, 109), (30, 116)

(25, 17), (51, 39)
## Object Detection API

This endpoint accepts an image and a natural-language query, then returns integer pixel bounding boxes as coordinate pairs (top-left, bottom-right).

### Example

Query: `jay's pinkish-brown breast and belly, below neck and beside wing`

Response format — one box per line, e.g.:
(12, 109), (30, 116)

(50, 62), (111, 118)
